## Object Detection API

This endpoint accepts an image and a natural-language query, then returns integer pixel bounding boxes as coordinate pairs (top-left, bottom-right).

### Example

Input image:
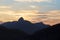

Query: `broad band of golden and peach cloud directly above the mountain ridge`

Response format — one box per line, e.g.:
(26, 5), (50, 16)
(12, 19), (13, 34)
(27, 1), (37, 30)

(0, 6), (60, 24)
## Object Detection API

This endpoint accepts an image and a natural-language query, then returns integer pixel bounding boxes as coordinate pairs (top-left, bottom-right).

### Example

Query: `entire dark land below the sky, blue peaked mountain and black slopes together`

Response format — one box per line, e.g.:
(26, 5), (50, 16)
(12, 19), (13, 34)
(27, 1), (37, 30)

(0, 18), (60, 40)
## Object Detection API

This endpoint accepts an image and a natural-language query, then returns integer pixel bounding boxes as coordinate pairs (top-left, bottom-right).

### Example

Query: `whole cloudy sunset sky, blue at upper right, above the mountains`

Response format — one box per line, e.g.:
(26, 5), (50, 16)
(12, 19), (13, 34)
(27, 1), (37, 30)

(0, 0), (60, 24)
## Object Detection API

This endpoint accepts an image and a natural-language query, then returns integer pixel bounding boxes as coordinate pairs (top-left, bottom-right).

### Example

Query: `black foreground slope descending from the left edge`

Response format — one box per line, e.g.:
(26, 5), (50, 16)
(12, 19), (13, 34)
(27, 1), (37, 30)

(0, 25), (27, 40)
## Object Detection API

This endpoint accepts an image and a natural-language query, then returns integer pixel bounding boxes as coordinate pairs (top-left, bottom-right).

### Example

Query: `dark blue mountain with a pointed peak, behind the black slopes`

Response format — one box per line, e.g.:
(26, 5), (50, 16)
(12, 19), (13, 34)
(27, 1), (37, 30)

(2, 17), (49, 34)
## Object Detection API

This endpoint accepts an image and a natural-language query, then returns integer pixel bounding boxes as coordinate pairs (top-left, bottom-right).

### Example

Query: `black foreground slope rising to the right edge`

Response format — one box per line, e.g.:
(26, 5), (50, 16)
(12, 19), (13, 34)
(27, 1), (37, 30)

(30, 24), (60, 40)
